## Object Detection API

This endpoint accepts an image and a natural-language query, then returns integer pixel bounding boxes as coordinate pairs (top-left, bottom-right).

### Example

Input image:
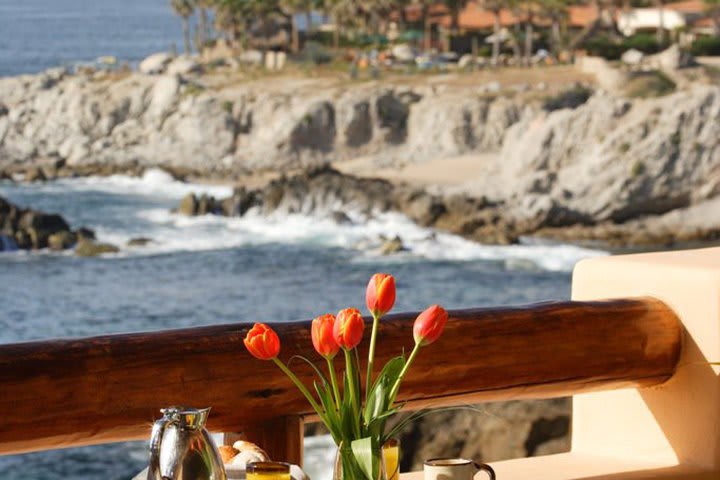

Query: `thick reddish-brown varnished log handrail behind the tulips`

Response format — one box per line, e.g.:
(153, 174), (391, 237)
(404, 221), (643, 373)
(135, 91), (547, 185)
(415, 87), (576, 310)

(0, 298), (681, 460)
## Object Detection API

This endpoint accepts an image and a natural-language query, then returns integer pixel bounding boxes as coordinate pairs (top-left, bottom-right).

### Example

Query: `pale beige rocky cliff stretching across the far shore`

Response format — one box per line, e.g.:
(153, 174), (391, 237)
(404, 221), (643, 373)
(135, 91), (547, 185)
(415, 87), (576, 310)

(0, 69), (720, 245)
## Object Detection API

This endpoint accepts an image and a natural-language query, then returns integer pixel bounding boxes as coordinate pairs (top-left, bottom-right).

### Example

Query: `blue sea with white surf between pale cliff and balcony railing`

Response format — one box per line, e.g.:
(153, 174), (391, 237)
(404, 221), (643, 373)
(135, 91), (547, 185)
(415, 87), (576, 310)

(0, 170), (603, 480)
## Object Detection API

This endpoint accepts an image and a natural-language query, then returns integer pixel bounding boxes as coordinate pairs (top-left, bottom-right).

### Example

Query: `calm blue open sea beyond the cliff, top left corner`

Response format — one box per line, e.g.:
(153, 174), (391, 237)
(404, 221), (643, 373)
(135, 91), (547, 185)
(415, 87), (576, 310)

(0, 0), (188, 76)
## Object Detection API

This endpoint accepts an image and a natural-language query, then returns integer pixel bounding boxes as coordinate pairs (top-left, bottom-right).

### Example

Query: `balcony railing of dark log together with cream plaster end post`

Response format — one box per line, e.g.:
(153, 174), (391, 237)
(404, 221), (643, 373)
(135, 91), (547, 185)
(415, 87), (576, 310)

(0, 250), (720, 479)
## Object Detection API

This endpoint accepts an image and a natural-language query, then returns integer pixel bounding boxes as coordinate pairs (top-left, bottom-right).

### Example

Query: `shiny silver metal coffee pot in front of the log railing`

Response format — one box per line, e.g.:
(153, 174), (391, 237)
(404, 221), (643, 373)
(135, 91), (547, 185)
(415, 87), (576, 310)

(147, 407), (227, 480)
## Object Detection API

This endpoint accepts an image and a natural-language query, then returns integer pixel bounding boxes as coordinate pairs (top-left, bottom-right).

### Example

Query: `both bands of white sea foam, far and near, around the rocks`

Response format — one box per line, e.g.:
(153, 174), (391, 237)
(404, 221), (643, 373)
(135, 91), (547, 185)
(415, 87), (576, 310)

(1, 169), (605, 271)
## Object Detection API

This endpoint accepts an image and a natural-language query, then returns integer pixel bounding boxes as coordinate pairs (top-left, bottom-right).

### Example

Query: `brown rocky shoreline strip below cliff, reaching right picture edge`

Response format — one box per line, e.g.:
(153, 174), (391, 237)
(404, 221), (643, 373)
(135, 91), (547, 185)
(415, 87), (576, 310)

(176, 166), (720, 248)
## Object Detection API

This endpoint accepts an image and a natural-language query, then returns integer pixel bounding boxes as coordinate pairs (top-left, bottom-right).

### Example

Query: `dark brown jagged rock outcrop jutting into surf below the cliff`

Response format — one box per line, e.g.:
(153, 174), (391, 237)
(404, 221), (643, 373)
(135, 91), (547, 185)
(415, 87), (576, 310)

(171, 166), (531, 248)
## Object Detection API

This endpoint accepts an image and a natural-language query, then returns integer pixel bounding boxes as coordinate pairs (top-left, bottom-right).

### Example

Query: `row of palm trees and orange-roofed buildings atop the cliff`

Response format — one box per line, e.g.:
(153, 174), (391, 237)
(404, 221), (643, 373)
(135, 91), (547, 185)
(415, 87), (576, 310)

(170, 0), (720, 59)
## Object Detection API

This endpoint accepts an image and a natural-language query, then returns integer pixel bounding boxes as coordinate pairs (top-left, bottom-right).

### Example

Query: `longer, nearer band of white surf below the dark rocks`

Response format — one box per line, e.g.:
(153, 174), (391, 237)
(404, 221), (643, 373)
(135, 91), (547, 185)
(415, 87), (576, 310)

(104, 209), (604, 271)
